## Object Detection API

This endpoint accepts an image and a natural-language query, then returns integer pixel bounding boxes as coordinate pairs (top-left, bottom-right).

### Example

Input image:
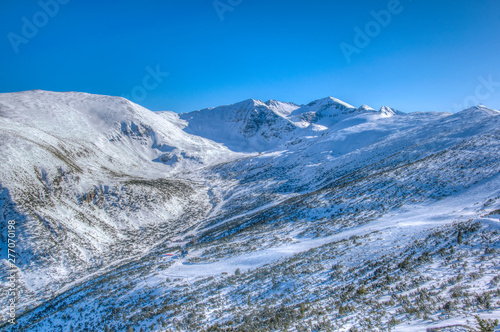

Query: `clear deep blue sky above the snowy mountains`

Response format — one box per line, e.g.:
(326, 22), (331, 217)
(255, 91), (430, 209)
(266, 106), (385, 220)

(0, 0), (500, 112)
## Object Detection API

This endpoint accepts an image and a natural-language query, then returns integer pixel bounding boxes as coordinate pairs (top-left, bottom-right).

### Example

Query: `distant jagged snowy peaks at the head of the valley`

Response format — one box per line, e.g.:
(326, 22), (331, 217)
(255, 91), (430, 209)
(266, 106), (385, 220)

(179, 97), (401, 152)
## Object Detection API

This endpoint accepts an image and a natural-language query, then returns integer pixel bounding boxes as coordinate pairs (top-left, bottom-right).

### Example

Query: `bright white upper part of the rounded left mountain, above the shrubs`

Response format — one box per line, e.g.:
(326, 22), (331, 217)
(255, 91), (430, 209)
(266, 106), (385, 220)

(0, 91), (237, 176)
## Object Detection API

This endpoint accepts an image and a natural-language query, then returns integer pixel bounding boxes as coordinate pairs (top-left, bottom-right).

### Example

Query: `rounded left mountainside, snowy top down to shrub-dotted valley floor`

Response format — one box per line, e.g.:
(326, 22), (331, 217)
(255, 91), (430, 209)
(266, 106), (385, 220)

(0, 91), (238, 316)
